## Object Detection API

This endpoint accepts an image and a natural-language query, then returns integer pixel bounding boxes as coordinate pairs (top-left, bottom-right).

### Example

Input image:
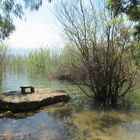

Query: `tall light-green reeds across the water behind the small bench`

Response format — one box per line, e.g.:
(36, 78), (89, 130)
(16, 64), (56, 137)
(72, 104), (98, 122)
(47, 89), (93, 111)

(7, 49), (59, 78)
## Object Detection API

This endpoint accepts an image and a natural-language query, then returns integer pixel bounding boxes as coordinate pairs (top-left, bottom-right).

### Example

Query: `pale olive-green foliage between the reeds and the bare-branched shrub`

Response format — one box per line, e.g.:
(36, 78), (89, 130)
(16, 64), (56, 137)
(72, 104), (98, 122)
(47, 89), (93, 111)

(53, 44), (81, 78)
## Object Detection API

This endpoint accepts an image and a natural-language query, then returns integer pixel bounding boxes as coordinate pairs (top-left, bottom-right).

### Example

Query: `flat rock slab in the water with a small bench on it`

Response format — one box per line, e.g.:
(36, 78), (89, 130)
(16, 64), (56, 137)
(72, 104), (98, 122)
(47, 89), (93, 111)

(0, 88), (70, 112)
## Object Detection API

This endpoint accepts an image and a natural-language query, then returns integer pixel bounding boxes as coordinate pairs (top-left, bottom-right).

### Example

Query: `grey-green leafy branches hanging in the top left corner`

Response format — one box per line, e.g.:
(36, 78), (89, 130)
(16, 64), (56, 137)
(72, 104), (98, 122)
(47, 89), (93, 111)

(0, 0), (51, 39)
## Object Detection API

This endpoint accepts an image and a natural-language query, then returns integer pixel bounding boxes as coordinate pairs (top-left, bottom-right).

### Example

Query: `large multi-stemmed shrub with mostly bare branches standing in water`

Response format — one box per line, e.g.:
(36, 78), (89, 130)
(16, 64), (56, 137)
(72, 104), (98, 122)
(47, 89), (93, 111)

(57, 0), (135, 106)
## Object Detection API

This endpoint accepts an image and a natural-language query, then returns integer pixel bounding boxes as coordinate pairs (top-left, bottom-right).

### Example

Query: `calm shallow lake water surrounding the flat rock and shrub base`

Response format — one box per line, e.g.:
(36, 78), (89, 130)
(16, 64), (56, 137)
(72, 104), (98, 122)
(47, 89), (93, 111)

(0, 72), (140, 140)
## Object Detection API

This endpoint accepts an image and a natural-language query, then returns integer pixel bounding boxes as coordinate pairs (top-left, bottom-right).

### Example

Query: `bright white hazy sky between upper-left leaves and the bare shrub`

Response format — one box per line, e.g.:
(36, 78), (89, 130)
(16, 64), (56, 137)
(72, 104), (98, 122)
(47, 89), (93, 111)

(6, 1), (64, 48)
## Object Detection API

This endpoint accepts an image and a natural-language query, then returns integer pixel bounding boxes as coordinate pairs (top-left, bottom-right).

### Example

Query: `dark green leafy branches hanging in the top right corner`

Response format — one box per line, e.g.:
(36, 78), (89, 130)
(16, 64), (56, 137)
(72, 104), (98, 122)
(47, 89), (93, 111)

(107, 0), (140, 39)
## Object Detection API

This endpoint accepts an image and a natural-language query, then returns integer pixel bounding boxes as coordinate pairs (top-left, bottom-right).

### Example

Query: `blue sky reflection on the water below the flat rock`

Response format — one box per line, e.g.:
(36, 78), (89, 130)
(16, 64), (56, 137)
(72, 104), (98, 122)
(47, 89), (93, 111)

(0, 112), (69, 139)
